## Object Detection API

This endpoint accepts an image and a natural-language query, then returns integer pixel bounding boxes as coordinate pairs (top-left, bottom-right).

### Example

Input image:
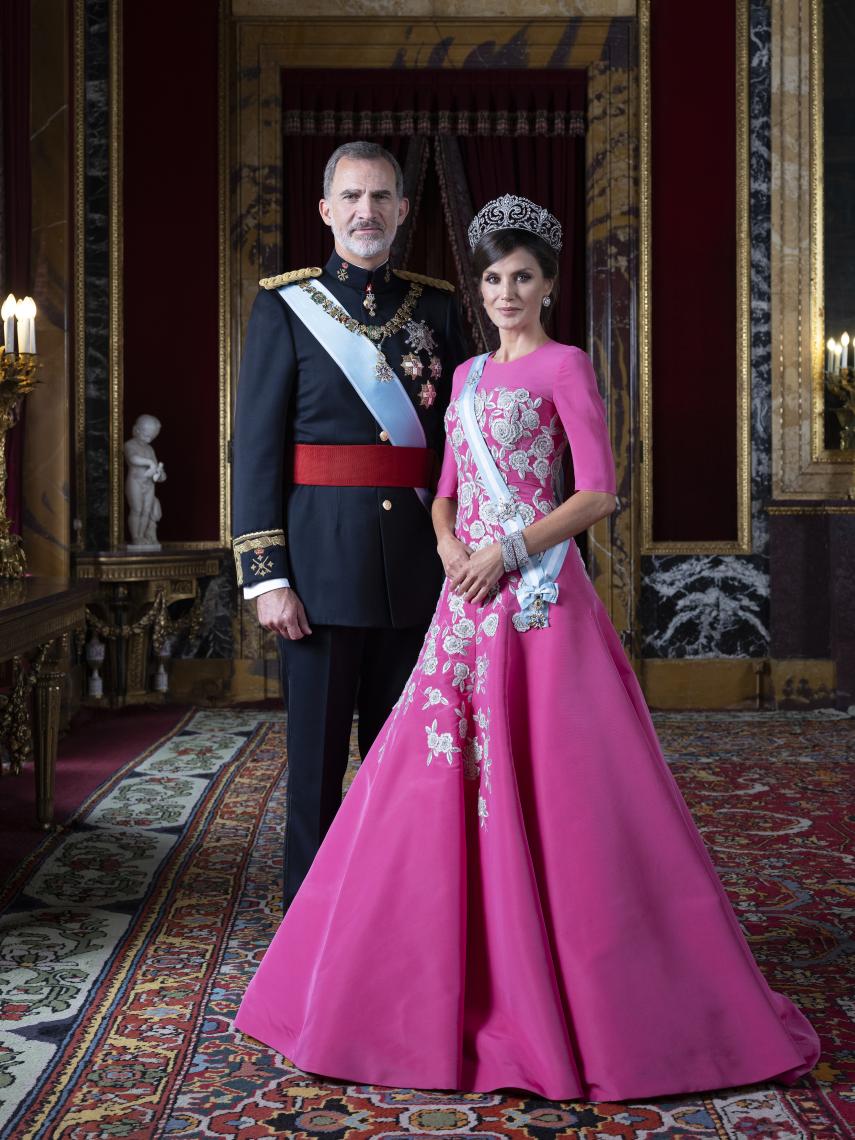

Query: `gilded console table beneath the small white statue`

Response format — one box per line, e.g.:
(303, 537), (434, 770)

(74, 545), (227, 707)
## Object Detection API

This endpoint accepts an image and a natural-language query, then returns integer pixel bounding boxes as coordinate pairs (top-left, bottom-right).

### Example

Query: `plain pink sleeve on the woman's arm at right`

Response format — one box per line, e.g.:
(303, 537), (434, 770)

(553, 349), (617, 495)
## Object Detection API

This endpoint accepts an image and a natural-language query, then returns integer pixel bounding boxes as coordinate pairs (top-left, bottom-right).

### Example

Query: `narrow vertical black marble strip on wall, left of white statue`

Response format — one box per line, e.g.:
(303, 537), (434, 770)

(82, 0), (109, 549)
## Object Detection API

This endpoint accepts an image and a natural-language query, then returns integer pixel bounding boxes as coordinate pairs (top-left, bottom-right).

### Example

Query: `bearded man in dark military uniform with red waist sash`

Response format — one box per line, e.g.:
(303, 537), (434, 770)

(234, 143), (466, 907)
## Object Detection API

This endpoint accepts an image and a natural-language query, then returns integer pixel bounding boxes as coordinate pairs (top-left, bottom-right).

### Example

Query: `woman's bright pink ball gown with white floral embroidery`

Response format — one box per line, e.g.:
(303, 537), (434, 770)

(235, 342), (819, 1100)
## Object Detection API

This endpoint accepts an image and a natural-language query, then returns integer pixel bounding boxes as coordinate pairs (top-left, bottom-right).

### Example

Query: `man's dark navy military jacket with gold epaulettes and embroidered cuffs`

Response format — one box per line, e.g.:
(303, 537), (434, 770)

(233, 254), (467, 628)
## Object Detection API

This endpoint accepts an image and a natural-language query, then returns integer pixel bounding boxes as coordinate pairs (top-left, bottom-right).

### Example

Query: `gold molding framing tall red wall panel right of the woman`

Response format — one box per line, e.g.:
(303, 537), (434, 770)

(638, 0), (752, 554)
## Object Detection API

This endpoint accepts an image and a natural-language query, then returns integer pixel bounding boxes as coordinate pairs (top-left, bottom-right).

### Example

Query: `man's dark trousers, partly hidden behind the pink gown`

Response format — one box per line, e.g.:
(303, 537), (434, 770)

(278, 625), (426, 907)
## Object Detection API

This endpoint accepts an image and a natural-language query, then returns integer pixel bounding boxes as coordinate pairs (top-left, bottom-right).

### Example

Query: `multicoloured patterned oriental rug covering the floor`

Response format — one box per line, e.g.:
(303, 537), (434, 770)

(0, 710), (855, 1140)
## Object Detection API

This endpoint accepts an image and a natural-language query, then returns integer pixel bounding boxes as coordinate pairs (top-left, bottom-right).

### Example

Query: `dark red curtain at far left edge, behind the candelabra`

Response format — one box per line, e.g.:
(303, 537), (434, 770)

(0, 0), (32, 535)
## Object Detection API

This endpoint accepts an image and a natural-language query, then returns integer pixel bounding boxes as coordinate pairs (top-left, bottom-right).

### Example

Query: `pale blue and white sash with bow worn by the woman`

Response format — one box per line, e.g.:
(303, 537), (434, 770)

(457, 352), (572, 632)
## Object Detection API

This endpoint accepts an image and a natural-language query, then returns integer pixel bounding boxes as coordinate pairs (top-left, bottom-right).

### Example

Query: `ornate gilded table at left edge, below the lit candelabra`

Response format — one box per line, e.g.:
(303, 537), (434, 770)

(0, 578), (96, 829)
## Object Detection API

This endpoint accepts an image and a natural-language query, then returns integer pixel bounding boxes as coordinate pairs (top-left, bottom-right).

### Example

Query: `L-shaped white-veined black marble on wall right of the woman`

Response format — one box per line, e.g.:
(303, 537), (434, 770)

(638, 0), (772, 658)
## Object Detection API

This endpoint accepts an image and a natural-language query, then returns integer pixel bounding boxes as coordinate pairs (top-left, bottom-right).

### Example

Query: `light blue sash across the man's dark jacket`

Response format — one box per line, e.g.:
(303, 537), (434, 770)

(277, 280), (431, 507)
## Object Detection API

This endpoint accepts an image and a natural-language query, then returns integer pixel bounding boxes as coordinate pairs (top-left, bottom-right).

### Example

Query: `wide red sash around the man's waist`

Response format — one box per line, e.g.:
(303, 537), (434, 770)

(291, 443), (438, 487)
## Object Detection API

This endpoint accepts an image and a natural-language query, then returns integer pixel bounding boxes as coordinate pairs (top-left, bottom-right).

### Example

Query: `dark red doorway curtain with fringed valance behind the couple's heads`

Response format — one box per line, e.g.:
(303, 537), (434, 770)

(283, 68), (586, 347)
